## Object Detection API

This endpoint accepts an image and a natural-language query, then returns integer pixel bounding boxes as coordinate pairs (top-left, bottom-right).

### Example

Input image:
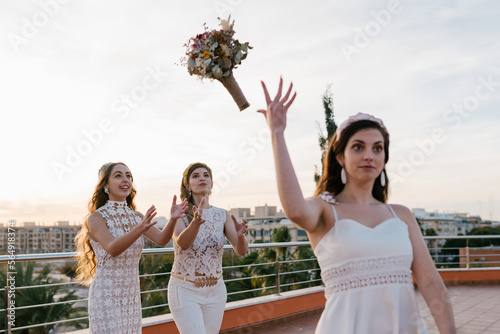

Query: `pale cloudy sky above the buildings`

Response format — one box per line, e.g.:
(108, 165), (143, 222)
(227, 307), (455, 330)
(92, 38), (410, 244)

(0, 0), (500, 224)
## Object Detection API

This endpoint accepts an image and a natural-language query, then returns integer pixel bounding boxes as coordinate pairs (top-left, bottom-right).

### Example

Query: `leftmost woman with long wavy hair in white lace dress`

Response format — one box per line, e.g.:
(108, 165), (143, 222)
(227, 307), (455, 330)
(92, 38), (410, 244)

(76, 162), (187, 334)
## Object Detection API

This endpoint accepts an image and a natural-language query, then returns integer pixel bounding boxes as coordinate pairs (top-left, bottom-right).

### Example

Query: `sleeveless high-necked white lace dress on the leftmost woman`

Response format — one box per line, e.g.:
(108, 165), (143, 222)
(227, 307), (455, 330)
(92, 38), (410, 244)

(89, 201), (144, 334)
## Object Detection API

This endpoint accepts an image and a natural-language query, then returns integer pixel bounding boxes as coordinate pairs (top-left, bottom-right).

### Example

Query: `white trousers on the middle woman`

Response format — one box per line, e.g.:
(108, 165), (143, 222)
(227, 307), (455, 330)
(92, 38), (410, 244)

(168, 277), (227, 334)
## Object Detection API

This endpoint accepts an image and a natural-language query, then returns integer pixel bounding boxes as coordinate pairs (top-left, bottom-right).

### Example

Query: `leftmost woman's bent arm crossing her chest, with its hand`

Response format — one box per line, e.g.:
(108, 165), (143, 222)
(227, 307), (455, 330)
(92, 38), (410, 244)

(87, 206), (156, 257)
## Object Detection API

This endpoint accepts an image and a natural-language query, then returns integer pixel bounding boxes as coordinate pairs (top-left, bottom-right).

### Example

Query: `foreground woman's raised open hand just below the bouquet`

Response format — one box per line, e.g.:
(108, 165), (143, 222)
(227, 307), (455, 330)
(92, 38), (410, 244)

(257, 78), (297, 132)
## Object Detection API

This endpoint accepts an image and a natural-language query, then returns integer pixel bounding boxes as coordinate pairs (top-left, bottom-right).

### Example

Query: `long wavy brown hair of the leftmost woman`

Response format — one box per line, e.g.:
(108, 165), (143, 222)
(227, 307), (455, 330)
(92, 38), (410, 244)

(75, 162), (137, 285)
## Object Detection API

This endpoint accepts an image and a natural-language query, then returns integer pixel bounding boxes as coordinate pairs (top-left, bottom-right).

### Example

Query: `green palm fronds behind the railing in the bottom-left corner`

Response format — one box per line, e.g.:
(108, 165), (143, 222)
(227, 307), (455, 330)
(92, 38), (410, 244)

(0, 262), (88, 334)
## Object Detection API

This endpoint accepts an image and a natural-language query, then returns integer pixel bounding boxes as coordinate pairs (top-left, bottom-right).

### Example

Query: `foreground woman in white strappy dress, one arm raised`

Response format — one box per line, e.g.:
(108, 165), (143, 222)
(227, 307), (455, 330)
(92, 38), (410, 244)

(259, 80), (456, 334)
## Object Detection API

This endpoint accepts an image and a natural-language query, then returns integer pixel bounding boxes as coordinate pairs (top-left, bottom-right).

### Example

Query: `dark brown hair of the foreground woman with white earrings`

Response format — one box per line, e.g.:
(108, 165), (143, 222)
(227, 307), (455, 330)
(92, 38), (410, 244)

(314, 120), (389, 203)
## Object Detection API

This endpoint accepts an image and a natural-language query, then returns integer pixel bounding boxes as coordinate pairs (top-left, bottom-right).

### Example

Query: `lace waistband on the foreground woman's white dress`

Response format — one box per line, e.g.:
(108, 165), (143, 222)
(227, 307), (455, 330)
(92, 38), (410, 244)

(321, 255), (413, 295)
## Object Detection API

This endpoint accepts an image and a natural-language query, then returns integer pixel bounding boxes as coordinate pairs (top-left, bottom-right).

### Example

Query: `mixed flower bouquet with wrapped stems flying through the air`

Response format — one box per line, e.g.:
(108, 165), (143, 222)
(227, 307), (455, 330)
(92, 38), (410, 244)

(183, 15), (252, 111)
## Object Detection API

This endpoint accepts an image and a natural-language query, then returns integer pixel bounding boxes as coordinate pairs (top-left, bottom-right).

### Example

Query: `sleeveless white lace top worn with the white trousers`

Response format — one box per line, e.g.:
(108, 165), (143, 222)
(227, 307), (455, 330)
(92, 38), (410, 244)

(172, 207), (226, 276)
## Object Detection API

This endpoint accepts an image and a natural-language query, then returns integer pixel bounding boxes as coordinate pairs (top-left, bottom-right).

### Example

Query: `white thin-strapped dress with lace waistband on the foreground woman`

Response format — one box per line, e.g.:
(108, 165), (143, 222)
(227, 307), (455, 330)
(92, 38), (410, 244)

(314, 196), (427, 334)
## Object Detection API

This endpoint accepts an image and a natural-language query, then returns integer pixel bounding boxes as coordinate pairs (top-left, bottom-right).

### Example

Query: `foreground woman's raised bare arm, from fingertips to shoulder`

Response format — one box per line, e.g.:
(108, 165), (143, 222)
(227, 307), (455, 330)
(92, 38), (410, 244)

(258, 78), (321, 231)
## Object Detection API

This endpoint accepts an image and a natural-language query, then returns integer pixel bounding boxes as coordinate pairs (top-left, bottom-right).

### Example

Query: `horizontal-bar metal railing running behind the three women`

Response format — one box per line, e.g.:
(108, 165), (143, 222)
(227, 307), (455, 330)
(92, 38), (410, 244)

(0, 235), (500, 334)
